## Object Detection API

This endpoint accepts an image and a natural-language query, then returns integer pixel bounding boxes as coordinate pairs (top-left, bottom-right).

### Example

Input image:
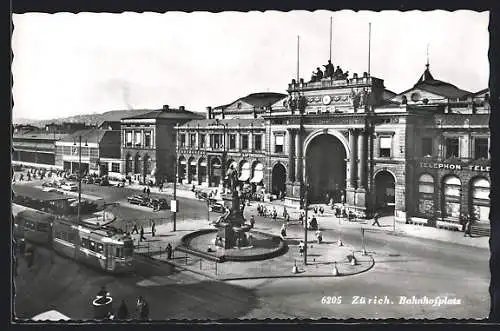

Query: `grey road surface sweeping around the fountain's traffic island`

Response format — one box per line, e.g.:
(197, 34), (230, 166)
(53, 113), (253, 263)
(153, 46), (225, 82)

(12, 180), (490, 319)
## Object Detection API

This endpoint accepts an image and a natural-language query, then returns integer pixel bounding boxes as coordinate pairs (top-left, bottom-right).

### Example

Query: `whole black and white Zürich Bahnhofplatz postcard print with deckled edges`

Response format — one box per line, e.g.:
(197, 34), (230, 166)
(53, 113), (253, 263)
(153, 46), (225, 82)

(10, 10), (492, 323)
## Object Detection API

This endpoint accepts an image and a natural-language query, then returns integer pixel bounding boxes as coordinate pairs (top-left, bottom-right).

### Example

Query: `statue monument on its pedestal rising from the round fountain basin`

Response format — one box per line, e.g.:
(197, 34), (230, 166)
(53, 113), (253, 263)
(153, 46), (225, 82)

(215, 165), (250, 249)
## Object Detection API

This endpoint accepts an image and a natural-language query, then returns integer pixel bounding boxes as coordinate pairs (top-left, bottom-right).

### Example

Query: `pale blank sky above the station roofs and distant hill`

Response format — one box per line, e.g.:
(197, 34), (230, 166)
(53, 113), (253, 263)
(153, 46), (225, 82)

(12, 10), (489, 120)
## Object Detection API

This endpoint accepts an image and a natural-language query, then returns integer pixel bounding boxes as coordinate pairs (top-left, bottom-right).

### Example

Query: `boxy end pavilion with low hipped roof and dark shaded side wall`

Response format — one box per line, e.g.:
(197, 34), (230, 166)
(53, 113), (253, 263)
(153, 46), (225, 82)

(121, 105), (203, 183)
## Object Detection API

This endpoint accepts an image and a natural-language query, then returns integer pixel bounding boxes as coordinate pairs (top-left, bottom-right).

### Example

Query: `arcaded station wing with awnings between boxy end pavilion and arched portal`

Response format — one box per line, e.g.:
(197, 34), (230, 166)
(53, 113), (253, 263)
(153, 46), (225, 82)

(177, 92), (286, 188)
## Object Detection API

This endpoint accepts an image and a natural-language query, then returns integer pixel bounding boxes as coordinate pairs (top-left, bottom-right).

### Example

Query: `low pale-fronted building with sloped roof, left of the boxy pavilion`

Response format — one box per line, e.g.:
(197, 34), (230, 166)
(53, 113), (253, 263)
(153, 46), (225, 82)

(56, 128), (121, 176)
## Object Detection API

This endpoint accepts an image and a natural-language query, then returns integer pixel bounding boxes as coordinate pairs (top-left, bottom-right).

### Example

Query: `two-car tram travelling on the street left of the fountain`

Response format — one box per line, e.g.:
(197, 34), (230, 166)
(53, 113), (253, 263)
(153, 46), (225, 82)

(12, 204), (134, 273)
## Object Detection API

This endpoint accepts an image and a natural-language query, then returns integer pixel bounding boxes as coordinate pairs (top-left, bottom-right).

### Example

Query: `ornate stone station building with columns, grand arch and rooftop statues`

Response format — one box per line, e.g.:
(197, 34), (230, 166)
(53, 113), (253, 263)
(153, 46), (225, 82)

(177, 64), (490, 228)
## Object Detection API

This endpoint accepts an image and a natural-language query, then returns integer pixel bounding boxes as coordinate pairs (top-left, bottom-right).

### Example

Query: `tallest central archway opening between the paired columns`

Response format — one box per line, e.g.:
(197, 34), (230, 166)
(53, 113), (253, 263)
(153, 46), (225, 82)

(306, 134), (346, 202)
